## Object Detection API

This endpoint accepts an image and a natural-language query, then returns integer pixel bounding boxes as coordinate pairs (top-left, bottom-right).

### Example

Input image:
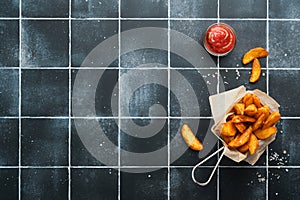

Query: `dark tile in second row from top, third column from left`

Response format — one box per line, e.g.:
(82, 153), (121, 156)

(71, 20), (118, 67)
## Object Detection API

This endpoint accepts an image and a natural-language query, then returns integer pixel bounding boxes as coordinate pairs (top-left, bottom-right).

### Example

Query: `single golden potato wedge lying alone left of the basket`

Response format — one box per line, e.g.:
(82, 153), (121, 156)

(181, 124), (203, 151)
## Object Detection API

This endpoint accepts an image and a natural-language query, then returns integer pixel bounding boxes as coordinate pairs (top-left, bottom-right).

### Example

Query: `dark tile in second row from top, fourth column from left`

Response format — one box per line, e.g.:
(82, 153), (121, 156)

(121, 20), (168, 68)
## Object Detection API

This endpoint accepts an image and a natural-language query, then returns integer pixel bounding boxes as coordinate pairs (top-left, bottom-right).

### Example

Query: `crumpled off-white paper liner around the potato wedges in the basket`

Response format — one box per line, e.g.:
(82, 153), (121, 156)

(209, 86), (279, 165)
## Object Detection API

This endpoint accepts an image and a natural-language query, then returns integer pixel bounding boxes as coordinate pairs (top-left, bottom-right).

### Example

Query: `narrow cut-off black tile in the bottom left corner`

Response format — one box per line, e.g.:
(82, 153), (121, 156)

(0, 169), (19, 200)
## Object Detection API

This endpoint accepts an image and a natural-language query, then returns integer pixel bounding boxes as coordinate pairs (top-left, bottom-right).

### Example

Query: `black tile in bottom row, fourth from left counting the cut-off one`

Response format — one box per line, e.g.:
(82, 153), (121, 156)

(121, 169), (168, 200)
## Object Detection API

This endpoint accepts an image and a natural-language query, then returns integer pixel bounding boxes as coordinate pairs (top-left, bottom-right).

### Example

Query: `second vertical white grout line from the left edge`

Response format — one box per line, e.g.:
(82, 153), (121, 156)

(68, 0), (72, 200)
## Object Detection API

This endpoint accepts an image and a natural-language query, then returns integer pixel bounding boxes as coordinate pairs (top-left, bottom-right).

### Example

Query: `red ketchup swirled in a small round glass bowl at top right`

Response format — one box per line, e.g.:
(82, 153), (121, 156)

(203, 23), (236, 56)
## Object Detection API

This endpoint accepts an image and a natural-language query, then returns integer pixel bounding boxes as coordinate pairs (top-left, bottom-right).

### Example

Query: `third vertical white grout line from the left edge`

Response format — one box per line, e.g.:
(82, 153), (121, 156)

(118, 0), (122, 200)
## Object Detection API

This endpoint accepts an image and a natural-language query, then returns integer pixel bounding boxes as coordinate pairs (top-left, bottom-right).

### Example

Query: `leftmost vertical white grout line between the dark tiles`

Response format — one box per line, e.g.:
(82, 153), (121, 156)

(18, 0), (22, 200)
